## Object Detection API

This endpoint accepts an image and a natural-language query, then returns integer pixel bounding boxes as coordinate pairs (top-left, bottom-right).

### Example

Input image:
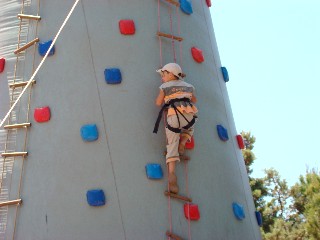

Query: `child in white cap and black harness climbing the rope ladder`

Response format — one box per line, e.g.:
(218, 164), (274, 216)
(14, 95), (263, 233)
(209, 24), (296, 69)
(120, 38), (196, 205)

(153, 63), (198, 193)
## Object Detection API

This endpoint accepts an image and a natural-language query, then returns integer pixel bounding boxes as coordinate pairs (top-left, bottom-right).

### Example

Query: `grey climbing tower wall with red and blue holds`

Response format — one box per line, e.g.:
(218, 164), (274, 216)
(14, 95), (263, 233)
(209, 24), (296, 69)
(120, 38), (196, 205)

(0, 0), (261, 240)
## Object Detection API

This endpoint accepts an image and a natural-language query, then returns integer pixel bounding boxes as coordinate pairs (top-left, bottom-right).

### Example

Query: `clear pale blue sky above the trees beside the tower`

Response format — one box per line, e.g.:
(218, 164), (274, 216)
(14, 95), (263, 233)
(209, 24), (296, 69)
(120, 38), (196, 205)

(211, 0), (320, 186)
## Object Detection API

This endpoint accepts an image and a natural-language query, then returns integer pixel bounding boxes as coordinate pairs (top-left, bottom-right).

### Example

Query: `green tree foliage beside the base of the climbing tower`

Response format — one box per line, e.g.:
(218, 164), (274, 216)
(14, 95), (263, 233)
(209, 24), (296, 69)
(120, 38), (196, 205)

(241, 131), (320, 240)
